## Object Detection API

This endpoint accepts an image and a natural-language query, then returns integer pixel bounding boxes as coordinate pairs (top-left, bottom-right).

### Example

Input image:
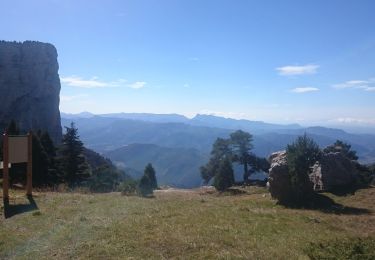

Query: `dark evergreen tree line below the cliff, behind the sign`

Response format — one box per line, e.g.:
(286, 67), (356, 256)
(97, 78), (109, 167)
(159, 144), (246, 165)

(0, 120), (158, 196)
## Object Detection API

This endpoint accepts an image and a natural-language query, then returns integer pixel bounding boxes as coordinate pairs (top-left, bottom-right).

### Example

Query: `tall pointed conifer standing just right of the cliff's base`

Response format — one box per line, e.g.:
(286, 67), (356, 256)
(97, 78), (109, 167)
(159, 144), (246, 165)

(59, 123), (90, 186)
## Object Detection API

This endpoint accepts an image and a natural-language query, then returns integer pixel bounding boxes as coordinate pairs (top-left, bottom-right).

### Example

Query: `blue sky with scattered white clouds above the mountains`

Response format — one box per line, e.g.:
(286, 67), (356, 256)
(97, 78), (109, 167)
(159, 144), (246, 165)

(0, 0), (375, 127)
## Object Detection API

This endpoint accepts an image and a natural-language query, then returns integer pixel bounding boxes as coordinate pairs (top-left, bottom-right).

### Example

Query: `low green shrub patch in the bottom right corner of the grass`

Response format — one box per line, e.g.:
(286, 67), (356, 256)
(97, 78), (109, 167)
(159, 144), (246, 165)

(305, 238), (375, 260)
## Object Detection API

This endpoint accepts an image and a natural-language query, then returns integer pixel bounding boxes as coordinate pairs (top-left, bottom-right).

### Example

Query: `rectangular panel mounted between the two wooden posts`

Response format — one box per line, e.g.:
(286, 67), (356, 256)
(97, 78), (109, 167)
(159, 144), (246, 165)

(9, 136), (28, 163)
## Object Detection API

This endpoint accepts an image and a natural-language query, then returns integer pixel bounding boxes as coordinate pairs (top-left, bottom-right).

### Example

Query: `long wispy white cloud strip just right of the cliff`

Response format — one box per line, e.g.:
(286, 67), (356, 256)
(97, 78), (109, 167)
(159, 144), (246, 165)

(60, 76), (146, 89)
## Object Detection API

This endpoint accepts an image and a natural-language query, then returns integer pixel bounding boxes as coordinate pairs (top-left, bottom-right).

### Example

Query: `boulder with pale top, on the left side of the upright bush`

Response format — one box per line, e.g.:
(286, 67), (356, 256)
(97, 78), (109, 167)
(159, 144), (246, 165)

(267, 151), (291, 202)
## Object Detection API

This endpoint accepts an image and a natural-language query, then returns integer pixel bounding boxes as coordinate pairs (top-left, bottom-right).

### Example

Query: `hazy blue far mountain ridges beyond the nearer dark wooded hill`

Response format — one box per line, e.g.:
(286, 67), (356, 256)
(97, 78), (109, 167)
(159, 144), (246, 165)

(61, 114), (375, 160)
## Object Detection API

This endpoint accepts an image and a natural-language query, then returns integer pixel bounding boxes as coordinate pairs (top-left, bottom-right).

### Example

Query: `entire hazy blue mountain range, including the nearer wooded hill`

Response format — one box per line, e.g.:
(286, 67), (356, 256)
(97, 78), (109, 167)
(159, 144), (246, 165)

(61, 112), (375, 187)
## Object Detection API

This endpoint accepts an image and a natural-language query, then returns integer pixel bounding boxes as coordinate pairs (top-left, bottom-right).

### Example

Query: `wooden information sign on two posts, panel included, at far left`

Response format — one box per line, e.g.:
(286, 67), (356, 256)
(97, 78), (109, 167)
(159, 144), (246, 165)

(3, 132), (33, 200)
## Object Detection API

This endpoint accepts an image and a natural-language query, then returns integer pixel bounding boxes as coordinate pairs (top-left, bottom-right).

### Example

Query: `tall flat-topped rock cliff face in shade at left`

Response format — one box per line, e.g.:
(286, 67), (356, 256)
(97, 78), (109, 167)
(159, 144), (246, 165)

(0, 41), (62, 143)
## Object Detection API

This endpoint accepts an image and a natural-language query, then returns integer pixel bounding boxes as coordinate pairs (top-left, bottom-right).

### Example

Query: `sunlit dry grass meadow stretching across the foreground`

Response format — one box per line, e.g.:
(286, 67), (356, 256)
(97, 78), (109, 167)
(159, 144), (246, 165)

(0, 187), (375, 259)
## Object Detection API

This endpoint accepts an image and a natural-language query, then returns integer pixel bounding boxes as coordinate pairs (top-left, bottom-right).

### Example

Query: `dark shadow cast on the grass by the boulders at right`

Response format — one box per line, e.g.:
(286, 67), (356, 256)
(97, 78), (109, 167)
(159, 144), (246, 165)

(287, 193), (372, 215)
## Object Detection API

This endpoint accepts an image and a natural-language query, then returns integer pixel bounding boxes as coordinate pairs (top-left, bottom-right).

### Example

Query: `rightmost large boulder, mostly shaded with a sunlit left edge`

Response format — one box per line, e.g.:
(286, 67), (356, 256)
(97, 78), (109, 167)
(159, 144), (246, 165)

(310, 152), (357, 191)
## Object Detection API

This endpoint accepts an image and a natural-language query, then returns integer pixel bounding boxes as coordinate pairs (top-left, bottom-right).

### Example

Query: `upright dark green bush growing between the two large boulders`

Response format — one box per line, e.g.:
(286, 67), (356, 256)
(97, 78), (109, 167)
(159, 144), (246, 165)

(286, 134), (321, 205)
